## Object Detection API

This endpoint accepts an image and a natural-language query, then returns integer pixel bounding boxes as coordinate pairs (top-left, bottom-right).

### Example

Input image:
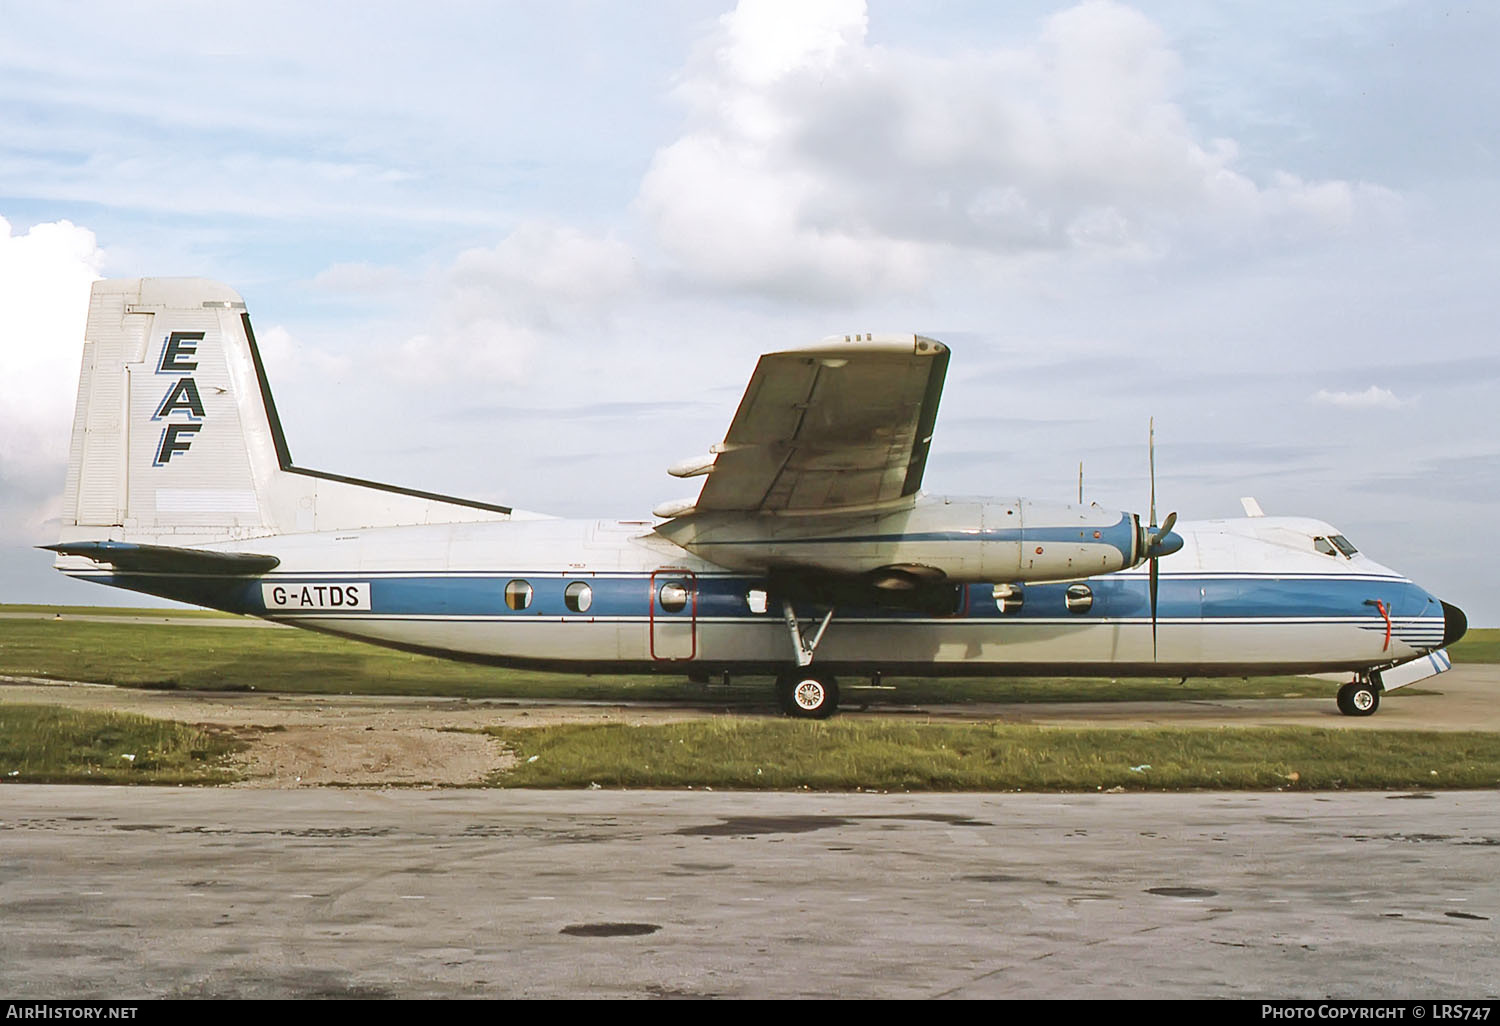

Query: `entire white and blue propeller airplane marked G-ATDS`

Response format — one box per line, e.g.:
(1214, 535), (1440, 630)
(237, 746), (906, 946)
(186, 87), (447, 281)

(47, 279), (1467, 717)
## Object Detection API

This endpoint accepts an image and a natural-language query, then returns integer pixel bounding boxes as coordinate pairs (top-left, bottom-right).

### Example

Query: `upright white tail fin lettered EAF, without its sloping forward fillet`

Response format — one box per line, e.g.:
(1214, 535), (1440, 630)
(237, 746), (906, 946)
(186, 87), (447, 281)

(63, 279), (279, 545)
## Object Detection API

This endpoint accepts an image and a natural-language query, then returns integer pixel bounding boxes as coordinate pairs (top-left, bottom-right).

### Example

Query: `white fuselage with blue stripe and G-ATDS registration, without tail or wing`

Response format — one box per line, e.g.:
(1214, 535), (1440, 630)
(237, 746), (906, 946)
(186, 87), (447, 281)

(68, 518), (1454, 677)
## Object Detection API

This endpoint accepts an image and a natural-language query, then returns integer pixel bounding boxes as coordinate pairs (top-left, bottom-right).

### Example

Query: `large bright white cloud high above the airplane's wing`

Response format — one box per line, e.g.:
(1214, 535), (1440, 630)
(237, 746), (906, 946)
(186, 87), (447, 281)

(639, 0), (1394, 297)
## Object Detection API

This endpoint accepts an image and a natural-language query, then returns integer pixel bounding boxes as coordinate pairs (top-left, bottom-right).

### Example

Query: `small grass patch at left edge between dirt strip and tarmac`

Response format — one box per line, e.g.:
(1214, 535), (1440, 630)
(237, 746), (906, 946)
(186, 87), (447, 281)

(0, 705), (245, 785)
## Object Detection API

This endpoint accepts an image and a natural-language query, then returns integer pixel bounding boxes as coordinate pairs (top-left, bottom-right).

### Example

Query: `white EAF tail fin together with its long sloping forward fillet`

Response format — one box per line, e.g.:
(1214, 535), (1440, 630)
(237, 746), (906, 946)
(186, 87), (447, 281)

(62, 278), (525, 548)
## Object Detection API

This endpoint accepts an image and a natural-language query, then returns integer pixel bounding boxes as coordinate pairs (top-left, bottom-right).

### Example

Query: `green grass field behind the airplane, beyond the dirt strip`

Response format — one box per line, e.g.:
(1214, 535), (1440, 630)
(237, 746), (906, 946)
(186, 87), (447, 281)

(0, 606), (1392, 708)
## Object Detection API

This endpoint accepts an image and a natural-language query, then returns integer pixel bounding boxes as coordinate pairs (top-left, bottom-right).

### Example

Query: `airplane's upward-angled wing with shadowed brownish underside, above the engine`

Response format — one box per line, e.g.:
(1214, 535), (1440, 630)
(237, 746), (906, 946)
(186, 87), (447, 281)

(695, 335), (948, 513)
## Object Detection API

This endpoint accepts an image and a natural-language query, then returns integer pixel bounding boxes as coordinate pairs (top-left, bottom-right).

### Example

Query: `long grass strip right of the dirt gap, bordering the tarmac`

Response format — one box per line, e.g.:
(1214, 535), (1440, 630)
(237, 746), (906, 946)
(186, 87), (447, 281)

(489, 719), (1500, 792)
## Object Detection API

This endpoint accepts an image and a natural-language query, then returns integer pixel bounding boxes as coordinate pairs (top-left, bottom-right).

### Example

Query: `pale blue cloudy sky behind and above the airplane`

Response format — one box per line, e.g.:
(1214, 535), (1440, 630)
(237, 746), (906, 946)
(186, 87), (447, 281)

(0, 0), (1500, 626)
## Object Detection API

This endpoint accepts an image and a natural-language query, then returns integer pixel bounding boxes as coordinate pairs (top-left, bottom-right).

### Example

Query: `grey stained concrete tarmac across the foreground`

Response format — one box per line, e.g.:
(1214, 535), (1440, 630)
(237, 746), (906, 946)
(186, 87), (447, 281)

(0, 786), (1500, 1001)
